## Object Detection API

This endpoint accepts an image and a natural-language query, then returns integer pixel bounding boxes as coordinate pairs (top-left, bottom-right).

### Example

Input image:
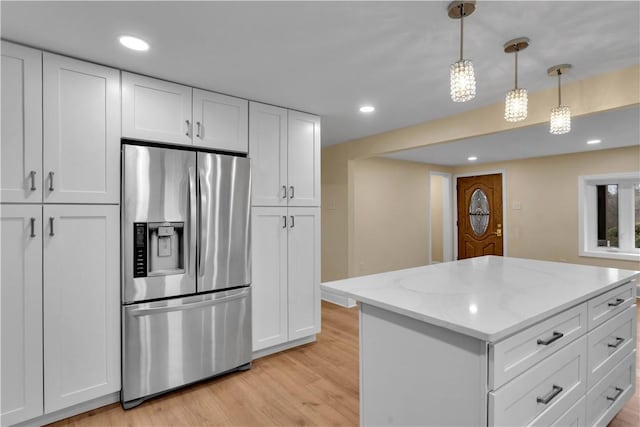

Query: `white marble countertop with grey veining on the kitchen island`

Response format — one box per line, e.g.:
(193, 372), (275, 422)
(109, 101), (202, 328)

(321, 256), (640, 342)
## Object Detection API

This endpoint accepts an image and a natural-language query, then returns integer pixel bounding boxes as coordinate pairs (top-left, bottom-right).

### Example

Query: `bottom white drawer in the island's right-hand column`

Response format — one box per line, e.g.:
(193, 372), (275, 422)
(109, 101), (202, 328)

(587, 350), (636, 426)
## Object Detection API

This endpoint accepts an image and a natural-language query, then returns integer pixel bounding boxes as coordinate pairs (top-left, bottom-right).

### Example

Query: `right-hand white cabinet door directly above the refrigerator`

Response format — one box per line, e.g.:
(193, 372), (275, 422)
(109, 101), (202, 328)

(193, 89), (249, 153)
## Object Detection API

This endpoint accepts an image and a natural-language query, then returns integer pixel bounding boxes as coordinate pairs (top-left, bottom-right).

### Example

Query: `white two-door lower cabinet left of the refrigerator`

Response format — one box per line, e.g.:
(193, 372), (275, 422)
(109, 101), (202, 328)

(1, 205), (120, 425)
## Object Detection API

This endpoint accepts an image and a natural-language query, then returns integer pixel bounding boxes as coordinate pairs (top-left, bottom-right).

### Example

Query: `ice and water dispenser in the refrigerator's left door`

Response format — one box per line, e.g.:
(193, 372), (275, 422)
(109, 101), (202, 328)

(133, 222), (185, 277)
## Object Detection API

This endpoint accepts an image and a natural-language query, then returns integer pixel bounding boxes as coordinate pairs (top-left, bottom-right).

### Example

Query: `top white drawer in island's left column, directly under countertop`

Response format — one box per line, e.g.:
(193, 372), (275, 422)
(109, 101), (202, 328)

(489, 303), (587, 390)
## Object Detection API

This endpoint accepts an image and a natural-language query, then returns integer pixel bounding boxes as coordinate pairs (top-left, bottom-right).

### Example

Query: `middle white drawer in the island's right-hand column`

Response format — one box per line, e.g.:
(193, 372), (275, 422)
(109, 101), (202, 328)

(587, 304), (636, 389)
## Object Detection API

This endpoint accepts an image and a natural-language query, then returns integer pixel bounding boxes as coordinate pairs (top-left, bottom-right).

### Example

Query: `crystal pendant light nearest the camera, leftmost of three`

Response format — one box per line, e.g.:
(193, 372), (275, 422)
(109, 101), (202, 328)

(448, 0), (476, 102)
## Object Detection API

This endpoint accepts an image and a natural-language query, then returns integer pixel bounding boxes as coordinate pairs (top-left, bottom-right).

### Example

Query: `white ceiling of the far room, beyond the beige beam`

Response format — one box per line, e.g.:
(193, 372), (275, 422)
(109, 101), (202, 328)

(384, 105), (640, 168)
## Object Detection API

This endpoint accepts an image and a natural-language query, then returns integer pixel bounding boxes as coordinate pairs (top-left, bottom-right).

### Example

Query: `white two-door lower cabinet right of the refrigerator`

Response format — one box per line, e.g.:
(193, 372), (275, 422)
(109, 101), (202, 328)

(251, 207), (320, 352)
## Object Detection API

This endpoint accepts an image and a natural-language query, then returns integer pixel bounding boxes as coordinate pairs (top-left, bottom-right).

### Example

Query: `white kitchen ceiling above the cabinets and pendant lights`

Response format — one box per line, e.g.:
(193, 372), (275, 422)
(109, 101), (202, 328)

(0, 0), (640, 146)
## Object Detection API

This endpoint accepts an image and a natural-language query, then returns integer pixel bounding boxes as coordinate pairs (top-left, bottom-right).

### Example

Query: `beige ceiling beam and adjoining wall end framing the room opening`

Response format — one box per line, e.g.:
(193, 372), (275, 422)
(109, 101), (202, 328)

(322, 66), (640, 281)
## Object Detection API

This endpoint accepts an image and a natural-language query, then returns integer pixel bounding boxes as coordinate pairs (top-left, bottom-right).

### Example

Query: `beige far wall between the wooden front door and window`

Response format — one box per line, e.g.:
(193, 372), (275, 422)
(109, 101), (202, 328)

(452, 145), (640, 270)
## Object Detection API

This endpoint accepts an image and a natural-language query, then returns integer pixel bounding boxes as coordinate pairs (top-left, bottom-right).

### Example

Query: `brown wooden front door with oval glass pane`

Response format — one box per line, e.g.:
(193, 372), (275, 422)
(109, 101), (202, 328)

(457, 174), (502, 259)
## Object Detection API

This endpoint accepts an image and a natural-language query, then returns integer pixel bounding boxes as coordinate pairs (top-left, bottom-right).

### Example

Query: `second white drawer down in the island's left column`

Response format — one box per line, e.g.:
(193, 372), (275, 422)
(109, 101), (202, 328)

(488, 336), (587, 426)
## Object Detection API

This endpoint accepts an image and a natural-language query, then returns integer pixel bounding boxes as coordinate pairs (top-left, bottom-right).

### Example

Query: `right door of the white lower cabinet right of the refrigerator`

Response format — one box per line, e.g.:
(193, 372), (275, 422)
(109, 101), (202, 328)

(288, 208), (320, 340)
